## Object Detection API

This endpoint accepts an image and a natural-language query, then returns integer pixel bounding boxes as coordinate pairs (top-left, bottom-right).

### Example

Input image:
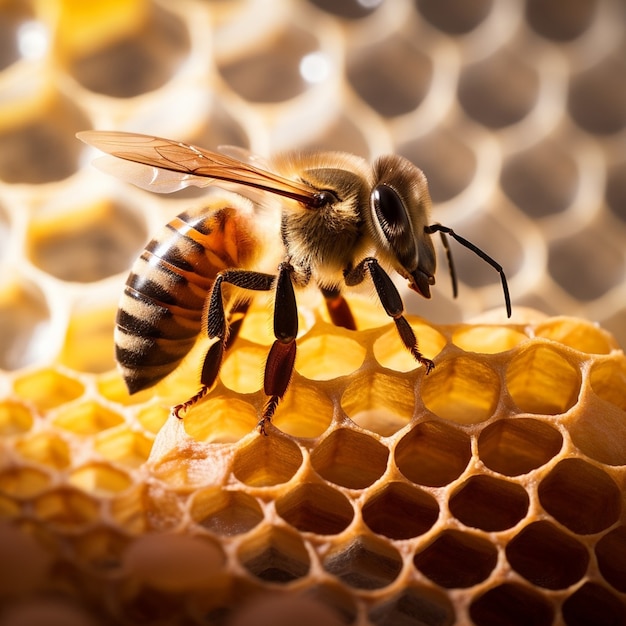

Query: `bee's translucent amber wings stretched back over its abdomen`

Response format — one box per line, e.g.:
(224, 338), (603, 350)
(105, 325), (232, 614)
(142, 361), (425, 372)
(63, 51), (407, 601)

(76, 130), (318, 207)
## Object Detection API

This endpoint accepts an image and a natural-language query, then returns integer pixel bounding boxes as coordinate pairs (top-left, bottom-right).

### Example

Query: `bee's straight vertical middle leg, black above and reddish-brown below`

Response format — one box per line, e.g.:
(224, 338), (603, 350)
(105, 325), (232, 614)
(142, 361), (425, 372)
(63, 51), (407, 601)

(259, 262), (298, 435)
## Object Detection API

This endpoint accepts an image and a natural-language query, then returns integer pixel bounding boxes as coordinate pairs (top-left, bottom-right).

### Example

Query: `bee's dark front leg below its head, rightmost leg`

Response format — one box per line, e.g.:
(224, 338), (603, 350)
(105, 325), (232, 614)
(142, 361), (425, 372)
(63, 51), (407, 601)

(344, 257), (435, 374)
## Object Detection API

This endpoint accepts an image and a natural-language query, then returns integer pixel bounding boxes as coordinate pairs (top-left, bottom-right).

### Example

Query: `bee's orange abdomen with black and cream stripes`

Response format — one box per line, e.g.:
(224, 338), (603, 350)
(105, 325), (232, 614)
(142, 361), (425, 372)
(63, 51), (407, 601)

(115, 208), (254, 393)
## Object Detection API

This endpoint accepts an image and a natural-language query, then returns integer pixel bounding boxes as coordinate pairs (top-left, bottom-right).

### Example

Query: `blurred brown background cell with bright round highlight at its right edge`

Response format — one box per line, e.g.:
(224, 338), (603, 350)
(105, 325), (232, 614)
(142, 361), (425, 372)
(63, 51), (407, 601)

(218, 24), (319, 103)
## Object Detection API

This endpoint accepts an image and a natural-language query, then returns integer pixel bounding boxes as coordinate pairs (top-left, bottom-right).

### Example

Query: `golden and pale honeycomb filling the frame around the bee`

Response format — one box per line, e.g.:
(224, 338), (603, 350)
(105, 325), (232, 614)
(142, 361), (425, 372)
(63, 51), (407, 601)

(0, 0), (626, 626)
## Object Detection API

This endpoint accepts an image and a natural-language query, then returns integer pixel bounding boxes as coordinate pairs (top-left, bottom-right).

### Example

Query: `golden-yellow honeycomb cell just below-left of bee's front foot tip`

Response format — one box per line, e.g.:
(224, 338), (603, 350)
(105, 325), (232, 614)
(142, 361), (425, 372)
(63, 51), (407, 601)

(341, 373), (415, 436)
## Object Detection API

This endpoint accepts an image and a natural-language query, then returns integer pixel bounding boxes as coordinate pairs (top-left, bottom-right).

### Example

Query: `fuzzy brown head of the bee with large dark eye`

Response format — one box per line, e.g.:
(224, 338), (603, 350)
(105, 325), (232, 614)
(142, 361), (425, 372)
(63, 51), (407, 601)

(370, 155), (436, 298)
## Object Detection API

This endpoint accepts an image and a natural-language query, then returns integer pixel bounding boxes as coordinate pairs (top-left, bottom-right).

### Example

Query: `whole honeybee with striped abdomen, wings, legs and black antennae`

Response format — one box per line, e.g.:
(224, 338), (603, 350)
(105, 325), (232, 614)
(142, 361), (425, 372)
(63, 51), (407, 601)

(77, 131), (511, 434)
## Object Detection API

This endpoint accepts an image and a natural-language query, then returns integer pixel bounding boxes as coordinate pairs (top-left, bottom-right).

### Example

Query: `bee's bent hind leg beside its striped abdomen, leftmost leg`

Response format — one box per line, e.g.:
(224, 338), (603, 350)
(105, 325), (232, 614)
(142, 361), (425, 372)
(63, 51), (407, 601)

(173, 269), (276, 418)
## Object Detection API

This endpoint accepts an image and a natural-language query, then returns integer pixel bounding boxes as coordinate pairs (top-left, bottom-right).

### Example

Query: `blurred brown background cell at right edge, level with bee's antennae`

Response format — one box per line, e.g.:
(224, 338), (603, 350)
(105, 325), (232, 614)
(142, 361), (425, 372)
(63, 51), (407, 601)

(548, 227), (626, 302)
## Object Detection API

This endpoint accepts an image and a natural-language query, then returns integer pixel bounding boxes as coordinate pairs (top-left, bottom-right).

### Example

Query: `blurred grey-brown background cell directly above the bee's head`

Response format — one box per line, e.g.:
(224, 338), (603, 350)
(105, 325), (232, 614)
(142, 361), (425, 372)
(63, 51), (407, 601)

(346, 34), (433, 117)
